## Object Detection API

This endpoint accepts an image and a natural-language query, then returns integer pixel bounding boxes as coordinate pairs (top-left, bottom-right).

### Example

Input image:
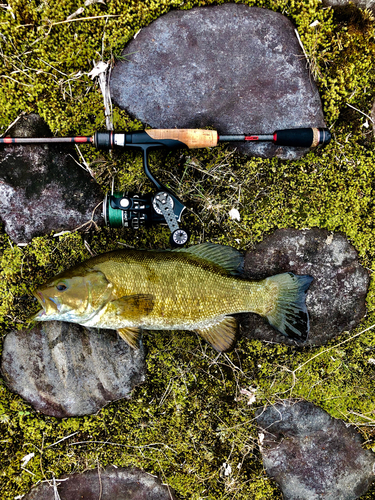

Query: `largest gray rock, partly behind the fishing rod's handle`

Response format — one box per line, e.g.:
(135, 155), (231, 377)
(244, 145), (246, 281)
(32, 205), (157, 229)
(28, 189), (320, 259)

(110, 3), (325, 159)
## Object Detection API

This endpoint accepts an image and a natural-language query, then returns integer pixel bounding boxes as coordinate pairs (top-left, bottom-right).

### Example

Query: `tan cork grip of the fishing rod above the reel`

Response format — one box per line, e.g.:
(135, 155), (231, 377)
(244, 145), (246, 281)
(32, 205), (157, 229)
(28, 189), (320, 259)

(145, 128), (218, 149)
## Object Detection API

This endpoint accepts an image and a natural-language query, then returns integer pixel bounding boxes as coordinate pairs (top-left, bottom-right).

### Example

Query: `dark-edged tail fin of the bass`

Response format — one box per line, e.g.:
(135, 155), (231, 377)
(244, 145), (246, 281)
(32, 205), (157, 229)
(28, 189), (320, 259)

(266, 273), (313, 341)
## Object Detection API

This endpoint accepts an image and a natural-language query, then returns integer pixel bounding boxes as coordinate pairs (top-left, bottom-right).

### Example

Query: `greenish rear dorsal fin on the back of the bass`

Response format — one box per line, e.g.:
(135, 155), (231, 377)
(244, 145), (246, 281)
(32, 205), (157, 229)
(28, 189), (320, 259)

(173, 243), (243, 275)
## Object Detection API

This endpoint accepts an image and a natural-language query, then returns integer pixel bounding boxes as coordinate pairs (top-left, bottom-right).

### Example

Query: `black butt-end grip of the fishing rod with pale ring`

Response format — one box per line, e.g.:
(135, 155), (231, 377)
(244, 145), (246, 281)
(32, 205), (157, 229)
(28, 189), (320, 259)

(273, 128), (331, 148)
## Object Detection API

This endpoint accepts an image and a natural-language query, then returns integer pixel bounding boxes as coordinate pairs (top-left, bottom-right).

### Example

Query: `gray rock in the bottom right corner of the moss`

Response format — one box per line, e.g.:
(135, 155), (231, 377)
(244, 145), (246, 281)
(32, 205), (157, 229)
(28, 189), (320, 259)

(256, 400), (375, 500)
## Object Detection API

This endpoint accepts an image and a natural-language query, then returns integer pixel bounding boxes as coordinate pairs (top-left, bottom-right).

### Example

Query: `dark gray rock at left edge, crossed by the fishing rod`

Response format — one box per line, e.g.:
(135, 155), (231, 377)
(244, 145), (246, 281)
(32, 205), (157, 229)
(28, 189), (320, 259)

(0, 115), (103, 243)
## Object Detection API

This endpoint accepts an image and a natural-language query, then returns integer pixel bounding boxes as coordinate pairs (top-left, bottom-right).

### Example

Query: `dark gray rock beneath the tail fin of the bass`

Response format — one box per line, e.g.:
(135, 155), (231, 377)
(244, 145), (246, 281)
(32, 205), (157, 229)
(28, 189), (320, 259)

(241, 229), (369, 345)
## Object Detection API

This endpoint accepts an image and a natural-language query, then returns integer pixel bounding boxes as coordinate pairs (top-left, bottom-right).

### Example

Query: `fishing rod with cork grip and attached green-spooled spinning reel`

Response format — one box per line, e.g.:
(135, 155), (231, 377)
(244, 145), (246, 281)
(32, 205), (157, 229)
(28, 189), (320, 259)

(0, 128), (331, 247)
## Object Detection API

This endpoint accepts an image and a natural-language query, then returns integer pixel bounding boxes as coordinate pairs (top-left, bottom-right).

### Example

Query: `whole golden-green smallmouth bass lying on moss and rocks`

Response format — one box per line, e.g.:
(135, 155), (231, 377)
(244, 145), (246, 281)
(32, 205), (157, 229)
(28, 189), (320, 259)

(33, 243), (313, 352)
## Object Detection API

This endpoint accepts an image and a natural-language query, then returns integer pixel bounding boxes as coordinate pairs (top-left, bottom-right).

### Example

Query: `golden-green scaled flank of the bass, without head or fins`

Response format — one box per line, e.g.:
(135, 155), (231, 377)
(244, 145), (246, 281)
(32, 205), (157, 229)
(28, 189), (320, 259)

(92, 252), (268, 329)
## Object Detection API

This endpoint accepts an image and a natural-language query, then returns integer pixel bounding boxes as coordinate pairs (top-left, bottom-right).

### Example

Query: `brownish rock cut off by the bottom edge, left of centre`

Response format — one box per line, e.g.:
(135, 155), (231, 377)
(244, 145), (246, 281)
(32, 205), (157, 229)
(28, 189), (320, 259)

(24, 467), (175, 500)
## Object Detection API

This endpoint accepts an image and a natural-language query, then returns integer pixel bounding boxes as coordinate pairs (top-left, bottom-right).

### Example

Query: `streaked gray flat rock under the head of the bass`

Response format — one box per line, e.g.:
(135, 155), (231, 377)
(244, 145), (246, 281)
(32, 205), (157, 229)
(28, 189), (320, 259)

(1, 321), (146, 418)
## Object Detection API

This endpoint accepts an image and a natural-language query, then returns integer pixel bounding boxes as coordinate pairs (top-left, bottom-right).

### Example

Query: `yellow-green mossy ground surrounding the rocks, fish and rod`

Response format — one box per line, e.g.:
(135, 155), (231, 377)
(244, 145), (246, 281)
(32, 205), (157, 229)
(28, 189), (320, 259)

(0, 0), (375, 500)
